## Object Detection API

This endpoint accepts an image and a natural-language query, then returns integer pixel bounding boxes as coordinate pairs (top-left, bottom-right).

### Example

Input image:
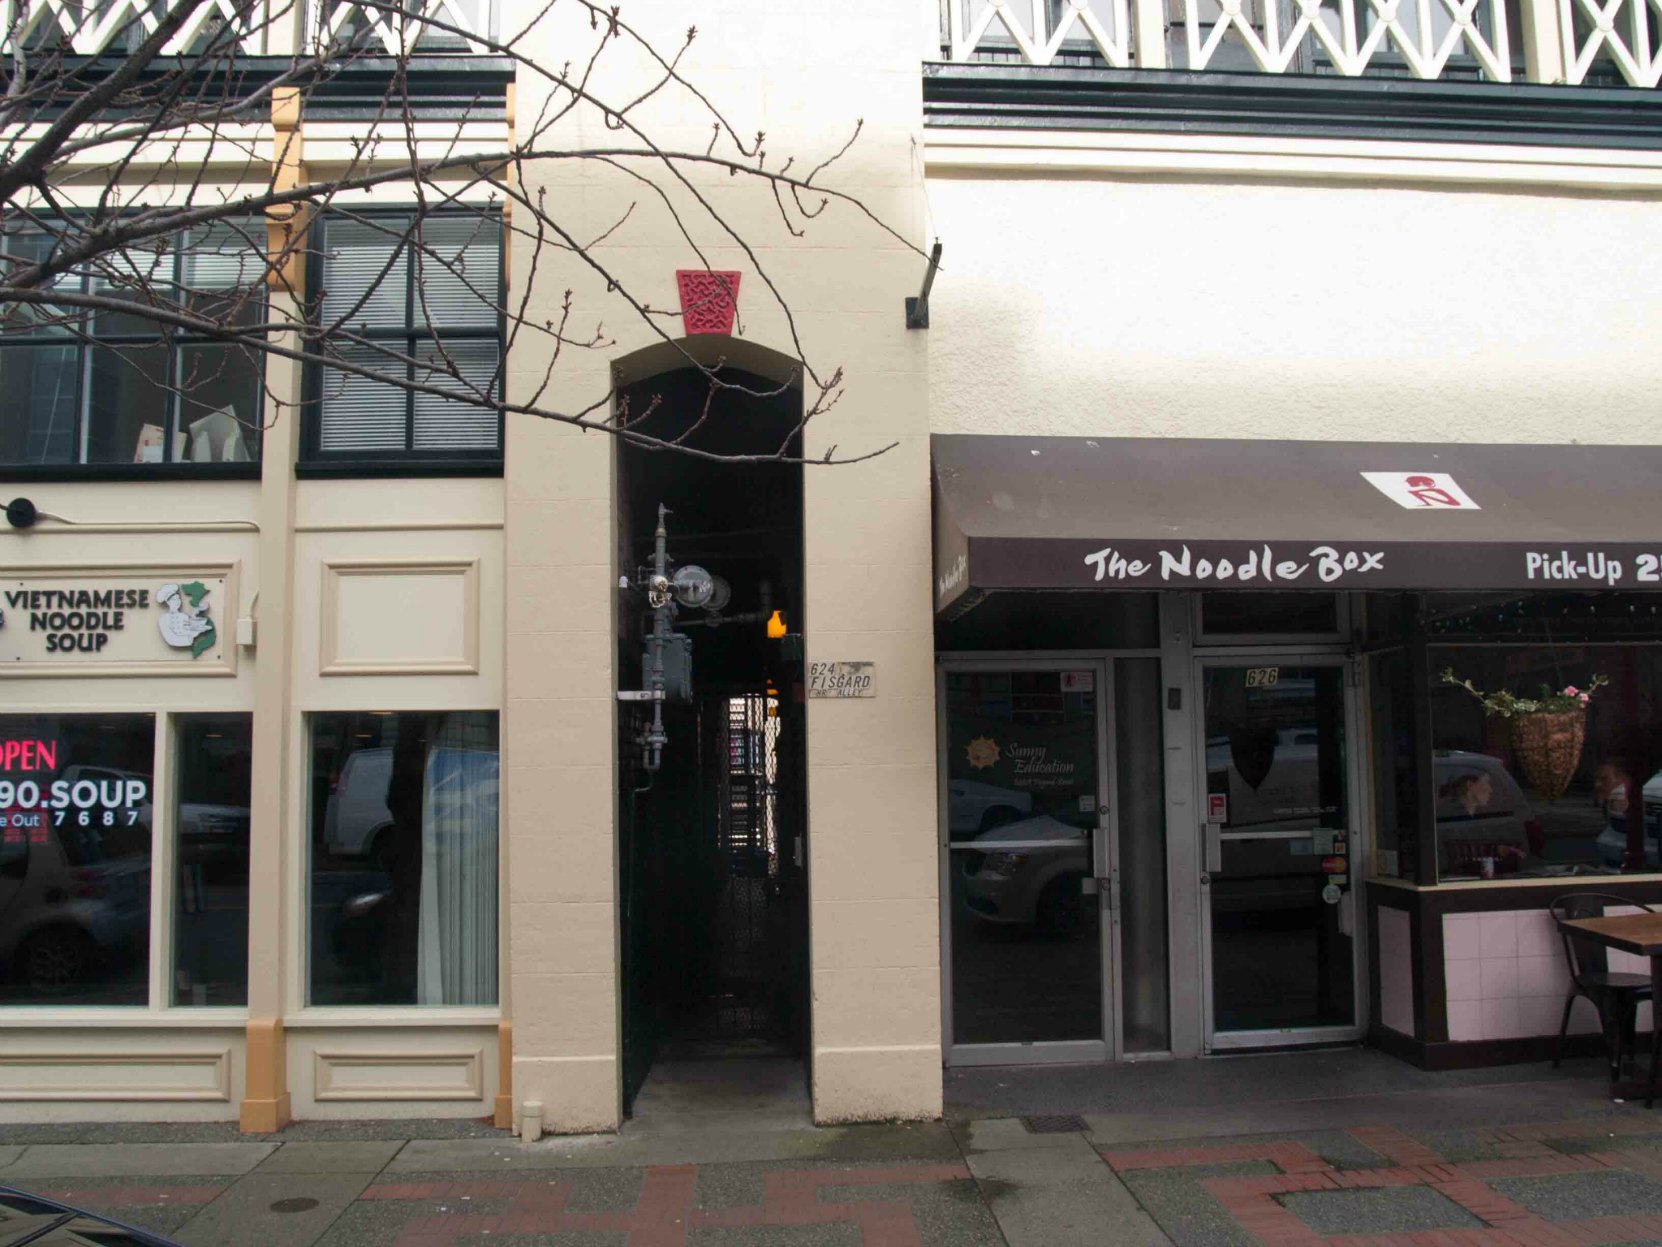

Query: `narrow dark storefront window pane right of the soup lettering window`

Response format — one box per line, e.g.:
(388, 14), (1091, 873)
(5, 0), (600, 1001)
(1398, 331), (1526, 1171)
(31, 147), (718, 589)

(171, 715), (253, 1006)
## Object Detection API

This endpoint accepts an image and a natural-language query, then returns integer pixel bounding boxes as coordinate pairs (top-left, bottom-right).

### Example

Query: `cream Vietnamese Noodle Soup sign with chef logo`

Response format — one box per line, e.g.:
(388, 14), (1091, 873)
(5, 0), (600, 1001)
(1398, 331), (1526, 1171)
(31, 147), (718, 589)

(0, 577), (224, 665)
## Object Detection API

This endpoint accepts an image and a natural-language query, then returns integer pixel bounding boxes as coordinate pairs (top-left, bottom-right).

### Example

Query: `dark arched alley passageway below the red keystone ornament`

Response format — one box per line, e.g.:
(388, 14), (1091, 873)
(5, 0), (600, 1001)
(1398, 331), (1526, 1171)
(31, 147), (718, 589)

(613, 339), (809, 1112)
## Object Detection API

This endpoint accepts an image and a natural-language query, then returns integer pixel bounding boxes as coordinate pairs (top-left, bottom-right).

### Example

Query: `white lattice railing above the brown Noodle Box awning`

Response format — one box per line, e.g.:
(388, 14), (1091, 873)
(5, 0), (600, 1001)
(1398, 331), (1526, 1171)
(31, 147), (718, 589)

(941, 0), (1662, 88)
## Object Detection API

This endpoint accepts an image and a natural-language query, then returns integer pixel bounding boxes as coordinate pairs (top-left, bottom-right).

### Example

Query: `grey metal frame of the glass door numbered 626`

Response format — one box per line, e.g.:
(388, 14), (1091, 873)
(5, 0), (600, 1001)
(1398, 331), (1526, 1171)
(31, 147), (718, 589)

(1190, 645), (1371, 1052)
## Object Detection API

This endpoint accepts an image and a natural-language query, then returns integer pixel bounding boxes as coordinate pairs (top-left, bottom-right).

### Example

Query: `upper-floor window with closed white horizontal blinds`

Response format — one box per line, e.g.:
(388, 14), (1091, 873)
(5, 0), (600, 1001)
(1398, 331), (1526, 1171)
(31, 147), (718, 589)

(306, 213), (502, 466)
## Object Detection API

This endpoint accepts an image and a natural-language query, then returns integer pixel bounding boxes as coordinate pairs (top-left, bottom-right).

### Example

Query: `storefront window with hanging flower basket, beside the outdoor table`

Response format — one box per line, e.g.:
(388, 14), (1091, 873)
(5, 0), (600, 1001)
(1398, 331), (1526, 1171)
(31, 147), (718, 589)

(1429, 648), (1662, 881)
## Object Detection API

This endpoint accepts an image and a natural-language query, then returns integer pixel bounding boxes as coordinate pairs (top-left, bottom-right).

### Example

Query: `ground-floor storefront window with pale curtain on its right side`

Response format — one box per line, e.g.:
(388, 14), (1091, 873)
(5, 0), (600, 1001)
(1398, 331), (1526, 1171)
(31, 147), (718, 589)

(309, 710), (499, 1004)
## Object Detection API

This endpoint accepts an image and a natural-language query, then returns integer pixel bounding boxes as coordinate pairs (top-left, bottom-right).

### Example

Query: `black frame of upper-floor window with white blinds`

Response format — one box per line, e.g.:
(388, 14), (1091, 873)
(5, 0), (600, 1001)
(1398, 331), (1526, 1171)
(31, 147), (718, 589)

(294, 205), (507, 479)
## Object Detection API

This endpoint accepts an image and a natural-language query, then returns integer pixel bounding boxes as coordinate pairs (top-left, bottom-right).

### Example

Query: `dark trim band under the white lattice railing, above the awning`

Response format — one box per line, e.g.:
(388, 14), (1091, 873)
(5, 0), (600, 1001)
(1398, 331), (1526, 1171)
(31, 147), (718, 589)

(924, 63), (1662, 151)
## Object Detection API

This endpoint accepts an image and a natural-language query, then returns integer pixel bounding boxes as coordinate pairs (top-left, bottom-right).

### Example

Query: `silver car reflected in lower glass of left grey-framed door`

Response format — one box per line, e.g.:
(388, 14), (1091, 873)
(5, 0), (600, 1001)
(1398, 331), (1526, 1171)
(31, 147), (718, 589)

(956, 815), (1095, 934)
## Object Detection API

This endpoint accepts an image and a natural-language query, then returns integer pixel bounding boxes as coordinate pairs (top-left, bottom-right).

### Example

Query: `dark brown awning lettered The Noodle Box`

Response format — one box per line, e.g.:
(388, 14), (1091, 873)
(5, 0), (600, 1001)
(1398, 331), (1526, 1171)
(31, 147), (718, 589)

(931, 434), (1662, 612)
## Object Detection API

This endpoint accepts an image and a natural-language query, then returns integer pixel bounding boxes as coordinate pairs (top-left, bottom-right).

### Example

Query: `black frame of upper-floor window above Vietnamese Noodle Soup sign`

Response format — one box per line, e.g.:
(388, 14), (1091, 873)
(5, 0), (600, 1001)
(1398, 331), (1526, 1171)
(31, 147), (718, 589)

(0, 218), (271, 482)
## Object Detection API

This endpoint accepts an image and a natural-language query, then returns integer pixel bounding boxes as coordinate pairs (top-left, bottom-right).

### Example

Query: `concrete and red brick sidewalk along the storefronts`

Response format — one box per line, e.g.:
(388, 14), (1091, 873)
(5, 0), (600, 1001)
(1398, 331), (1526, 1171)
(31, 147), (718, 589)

(0, 1051), (1662, 1247)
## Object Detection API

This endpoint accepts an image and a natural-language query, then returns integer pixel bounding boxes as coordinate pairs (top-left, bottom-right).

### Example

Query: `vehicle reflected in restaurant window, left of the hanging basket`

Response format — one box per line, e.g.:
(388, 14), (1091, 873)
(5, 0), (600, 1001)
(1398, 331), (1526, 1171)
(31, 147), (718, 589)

(1431, 750), (1546, 875)
